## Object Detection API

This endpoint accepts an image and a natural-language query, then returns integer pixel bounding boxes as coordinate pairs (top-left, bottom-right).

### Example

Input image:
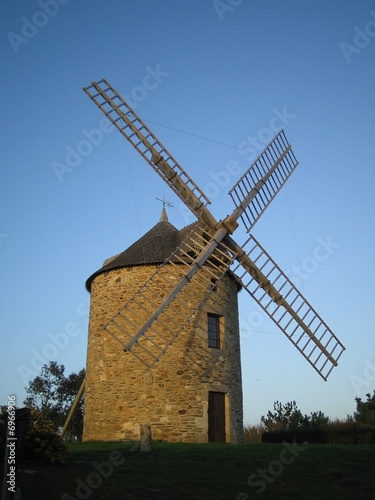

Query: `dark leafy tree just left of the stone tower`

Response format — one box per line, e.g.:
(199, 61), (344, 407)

(24, 361), (85, 441)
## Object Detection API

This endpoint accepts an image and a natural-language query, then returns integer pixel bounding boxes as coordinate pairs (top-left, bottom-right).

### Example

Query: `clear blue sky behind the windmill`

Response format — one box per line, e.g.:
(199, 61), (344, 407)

(0, 0), (375, 423)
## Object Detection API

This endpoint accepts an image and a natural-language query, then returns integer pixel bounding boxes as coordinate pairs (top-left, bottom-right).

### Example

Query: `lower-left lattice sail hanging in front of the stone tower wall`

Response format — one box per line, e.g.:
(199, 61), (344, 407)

(102, 224), (234, 368)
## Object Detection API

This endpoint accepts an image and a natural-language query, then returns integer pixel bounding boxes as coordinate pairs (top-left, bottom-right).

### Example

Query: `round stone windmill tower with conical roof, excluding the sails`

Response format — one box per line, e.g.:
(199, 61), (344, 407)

(83, 208), (242, 442)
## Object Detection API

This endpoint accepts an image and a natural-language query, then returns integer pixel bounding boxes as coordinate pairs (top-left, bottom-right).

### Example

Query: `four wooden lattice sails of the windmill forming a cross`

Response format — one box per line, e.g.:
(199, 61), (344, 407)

(61, 79), (345, 442)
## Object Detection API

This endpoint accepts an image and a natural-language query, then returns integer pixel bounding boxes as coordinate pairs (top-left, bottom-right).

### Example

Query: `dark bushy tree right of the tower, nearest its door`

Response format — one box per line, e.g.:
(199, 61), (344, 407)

(260, 401), (308, 431)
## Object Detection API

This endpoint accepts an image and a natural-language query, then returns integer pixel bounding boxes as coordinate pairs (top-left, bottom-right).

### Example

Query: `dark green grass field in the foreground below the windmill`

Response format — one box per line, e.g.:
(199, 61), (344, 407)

(10, 442), (375, 500)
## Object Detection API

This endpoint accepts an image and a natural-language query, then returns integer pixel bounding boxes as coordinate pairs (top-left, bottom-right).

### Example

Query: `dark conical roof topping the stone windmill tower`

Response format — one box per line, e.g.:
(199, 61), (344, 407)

(86, 213), (197, 292)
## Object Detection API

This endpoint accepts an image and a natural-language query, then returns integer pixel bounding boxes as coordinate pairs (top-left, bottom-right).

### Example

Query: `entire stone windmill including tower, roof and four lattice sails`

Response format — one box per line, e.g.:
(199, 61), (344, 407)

(63, 80), (345, 442)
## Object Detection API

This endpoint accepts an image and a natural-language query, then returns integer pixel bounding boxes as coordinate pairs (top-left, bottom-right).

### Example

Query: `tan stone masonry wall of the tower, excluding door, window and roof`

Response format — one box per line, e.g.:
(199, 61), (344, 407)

(83, 266), (243, 442)
